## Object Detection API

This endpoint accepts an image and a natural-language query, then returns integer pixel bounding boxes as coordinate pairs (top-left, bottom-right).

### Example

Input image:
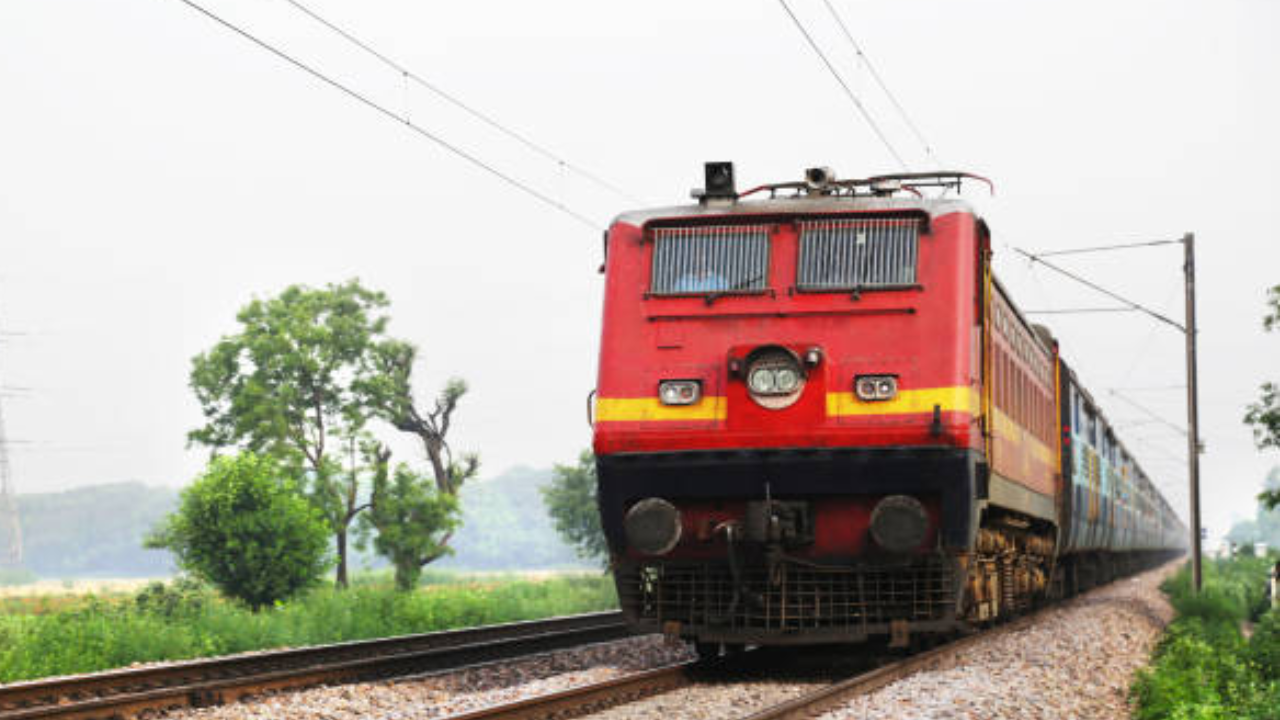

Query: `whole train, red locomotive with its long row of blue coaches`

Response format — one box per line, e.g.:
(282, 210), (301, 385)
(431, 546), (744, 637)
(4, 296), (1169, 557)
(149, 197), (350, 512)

(590, 163), (1187, 653)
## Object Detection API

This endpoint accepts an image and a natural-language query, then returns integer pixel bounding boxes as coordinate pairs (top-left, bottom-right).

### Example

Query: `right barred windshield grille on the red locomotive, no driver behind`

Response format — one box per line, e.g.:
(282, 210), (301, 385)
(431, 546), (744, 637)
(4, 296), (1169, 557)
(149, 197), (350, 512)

(796, 218), (920, 290)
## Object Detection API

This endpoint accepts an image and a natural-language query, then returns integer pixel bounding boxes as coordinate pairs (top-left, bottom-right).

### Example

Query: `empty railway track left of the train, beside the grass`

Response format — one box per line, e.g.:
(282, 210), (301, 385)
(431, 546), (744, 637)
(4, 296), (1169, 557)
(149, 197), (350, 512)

(0, 604), (628, 720)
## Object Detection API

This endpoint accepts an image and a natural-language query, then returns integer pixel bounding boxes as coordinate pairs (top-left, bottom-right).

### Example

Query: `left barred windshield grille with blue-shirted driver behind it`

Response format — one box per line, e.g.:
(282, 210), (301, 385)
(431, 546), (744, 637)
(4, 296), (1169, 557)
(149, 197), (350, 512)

(649, 225), (769, 295)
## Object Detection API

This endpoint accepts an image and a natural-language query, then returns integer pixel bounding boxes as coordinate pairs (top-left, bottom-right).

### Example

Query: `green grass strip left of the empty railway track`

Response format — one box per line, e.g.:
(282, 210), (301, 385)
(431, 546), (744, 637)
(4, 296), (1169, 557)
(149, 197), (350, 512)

(0, 574), (617, 682)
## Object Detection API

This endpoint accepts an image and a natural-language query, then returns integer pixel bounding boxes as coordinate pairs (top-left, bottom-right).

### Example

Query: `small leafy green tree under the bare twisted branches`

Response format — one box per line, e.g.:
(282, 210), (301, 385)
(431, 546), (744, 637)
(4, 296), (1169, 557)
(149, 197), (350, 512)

(361, 446), (460, 591)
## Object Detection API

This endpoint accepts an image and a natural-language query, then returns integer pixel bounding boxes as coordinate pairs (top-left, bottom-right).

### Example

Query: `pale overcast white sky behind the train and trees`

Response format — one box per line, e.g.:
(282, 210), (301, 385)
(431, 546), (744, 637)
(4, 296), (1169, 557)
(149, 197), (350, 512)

(0, 0), (1280, 534)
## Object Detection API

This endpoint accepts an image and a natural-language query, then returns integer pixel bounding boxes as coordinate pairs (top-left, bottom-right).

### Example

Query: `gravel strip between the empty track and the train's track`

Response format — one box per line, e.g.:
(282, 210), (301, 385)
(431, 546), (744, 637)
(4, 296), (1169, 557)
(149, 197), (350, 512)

(166, 635), (692, 720)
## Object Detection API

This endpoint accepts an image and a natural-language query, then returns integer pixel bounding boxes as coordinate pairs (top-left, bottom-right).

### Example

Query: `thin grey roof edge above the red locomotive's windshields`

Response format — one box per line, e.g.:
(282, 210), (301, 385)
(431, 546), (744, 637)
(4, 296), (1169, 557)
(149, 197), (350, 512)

(613, 195), (975, 227)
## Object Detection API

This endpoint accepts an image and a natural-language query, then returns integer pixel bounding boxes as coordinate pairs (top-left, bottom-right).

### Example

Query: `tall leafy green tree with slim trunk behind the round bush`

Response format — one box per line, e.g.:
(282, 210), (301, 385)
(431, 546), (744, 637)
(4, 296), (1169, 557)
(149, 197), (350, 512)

(188, 279), (396, 587)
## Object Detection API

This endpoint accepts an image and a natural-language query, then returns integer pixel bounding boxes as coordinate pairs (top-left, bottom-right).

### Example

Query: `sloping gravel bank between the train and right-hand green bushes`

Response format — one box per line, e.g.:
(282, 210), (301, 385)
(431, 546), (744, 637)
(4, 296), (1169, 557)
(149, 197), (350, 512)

(823, 562), (1179, 720)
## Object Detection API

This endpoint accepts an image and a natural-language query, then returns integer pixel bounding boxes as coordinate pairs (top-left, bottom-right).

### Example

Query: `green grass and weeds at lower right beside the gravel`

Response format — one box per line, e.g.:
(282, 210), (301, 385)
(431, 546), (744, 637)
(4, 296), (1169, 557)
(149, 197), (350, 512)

(1133, 557), (1280, 720)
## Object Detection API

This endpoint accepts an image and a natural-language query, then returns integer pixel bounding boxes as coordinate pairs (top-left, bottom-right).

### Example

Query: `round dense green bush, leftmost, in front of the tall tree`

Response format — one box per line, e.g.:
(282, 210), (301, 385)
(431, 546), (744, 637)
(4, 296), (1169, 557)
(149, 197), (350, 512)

(146, 452), (329, 610)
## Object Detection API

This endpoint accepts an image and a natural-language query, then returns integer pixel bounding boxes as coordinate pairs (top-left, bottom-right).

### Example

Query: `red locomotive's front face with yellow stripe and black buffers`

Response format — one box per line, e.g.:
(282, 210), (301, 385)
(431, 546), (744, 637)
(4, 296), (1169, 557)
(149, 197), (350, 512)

(594, 164), (986, 647)
